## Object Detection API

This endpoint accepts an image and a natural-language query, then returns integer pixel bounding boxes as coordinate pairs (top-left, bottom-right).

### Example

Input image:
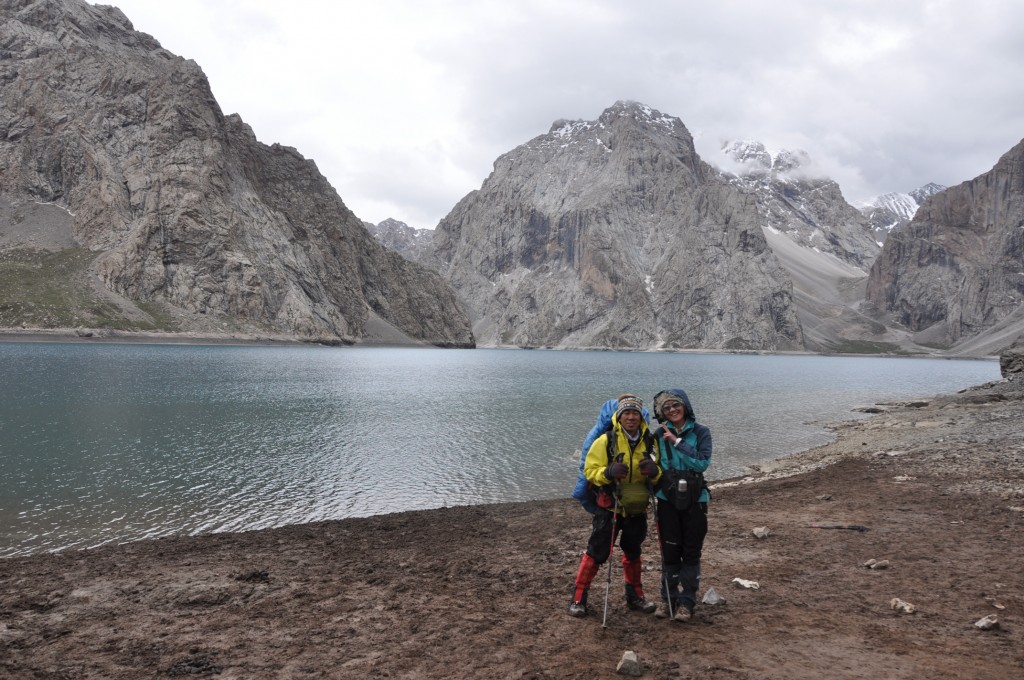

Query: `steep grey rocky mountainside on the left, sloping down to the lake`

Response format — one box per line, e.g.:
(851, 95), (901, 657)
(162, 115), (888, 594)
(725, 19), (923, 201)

(0, 0), (473, 346)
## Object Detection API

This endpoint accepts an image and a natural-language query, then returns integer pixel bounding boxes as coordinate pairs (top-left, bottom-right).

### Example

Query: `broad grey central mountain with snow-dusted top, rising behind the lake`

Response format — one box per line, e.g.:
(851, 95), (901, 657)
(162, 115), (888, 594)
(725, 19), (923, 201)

(425, 101), (803, 349)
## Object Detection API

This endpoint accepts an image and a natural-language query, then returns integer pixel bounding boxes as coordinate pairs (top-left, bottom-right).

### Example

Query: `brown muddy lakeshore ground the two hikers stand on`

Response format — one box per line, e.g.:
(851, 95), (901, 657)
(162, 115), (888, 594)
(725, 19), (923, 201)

(0, 383), (1024, 680)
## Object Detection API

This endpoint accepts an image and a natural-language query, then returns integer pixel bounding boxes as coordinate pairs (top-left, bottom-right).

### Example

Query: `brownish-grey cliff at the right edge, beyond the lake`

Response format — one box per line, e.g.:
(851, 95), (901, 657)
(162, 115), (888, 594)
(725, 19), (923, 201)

(866, 141), (1024, 349)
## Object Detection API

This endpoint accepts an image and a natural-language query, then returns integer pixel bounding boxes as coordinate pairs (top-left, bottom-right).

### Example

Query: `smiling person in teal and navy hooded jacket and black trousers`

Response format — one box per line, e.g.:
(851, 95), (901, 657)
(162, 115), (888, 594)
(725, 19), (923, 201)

(654, 388), (712, 623)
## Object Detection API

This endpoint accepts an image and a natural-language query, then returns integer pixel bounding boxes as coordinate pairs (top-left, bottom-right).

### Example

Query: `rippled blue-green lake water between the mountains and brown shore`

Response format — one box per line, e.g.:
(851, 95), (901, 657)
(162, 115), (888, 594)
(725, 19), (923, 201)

(0, 343), (999, 556)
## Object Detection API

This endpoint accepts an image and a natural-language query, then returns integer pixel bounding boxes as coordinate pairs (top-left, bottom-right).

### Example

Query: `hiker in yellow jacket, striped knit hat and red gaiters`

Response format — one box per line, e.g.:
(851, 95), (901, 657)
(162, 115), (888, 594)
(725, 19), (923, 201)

(569, 394), (662, 617)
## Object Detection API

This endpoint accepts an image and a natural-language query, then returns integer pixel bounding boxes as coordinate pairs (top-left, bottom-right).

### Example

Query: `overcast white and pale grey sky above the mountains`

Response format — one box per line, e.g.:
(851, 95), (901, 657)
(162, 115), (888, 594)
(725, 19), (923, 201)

(110, 0), (1024, 227)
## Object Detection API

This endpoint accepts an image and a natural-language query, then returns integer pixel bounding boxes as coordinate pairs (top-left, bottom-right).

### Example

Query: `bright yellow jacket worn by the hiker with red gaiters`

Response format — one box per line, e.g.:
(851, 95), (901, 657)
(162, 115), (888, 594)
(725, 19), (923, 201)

(583, 414), (662, 515)
